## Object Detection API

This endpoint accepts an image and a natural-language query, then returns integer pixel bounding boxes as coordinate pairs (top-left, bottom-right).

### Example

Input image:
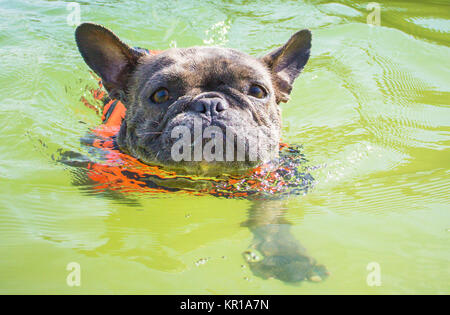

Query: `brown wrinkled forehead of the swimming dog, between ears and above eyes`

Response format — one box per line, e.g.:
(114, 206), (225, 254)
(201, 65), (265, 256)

(136, 47), (271, 91)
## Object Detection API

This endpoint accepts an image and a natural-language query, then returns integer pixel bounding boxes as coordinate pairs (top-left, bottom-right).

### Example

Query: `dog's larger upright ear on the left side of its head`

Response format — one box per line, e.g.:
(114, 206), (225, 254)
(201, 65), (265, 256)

(75, 23), (143, 101)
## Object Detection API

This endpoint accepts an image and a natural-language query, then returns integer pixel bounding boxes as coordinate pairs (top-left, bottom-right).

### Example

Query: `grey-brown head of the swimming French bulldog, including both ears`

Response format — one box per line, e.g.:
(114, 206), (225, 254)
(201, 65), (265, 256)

(76, 23), (311, 177)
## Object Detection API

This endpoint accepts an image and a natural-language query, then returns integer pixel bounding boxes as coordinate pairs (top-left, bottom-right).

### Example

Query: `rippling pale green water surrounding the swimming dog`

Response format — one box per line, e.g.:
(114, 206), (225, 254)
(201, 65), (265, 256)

(0, 0), (450, 294)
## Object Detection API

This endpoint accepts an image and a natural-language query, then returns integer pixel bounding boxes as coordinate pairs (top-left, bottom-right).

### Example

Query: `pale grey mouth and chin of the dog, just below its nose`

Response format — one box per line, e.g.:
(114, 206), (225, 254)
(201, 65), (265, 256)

(132, 112), (278, 176)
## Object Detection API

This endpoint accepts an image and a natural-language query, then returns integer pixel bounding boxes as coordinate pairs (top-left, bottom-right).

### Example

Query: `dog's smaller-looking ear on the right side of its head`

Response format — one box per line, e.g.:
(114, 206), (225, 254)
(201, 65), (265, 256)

(261, 30), (311, 103)
